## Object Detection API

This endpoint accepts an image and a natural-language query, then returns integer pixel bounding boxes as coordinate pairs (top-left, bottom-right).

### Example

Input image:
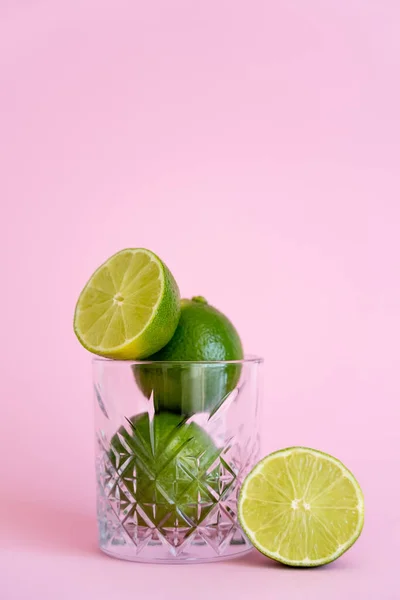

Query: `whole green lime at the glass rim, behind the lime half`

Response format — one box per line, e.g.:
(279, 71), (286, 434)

(134, 296), (243, 415)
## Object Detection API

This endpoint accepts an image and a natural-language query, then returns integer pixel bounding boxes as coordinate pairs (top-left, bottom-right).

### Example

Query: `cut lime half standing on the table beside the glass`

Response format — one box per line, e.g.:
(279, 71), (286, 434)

(238, 447), (364, 567)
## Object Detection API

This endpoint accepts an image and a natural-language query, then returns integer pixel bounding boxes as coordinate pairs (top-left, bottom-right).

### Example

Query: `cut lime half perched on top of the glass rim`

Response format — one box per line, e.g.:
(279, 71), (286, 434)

(74, 248), (180, 359)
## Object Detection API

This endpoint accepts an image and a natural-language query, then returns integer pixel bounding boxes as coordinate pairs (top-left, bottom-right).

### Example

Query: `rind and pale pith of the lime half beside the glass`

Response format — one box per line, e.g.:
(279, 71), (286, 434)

(238, 446), (364, 567)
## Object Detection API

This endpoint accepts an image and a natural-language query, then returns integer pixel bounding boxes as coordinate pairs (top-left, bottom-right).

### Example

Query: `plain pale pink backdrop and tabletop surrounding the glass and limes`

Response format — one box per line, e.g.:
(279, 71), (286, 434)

(0, 0), (400, 600)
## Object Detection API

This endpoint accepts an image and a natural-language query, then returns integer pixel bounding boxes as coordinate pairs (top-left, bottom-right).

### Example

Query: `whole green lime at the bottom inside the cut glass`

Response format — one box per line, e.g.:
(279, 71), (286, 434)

(109, 413), (220, 527)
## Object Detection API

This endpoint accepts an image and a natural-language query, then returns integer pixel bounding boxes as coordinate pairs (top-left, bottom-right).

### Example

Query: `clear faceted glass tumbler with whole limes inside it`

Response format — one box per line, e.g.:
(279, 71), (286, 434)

(93, 357), (262, 563)
